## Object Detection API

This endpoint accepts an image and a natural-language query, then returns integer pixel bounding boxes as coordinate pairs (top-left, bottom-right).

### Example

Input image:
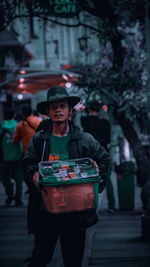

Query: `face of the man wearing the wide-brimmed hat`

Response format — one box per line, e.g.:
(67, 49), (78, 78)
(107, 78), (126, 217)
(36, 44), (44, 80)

(47, 100), (72, 124)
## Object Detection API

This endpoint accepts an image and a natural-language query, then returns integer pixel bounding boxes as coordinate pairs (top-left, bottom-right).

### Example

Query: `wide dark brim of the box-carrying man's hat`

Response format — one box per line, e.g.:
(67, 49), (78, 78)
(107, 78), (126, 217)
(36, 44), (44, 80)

(36, 96), (81, 115)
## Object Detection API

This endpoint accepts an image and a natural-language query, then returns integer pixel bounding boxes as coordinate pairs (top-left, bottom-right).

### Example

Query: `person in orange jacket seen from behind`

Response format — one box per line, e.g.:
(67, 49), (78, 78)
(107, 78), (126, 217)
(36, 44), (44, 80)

(14, 106), (41, 153)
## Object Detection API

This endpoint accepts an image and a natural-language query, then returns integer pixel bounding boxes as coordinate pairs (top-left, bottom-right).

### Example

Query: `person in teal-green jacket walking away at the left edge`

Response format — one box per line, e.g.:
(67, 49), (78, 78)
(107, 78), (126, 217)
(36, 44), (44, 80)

(0, 108), (23, 207)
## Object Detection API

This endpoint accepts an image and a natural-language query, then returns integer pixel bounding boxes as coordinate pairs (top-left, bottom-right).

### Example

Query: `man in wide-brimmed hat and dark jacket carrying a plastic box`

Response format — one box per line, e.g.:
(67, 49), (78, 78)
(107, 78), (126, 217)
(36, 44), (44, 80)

(23, 86), (110, 267)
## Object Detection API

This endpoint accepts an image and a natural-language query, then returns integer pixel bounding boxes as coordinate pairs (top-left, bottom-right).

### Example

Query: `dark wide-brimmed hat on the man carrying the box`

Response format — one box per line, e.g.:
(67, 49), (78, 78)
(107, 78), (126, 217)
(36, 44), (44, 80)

(37, 86), (80, 115)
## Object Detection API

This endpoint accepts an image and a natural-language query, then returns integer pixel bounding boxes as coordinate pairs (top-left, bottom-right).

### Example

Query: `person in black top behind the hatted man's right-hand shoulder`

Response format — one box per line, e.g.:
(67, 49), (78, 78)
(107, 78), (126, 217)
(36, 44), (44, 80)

(81, 101), (115, 213)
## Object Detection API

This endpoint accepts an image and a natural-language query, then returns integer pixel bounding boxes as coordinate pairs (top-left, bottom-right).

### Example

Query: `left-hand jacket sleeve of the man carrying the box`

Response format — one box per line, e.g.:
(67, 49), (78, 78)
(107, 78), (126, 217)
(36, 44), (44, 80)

(22, 136), (40, 185)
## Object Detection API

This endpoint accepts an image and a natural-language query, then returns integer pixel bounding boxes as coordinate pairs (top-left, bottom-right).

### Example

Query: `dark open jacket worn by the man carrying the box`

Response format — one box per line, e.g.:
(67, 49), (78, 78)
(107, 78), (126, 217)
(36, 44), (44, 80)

(23, 122), (110, 233)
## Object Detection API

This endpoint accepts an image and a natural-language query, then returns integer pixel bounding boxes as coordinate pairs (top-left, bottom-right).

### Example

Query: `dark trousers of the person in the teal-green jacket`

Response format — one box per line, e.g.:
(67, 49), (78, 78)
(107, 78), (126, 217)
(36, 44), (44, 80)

(2, 161), (23, 204)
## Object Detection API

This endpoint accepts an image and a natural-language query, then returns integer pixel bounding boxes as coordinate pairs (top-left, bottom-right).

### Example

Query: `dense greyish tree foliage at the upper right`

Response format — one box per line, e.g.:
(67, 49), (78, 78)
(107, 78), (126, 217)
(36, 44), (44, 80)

(73, 21), (149, 125)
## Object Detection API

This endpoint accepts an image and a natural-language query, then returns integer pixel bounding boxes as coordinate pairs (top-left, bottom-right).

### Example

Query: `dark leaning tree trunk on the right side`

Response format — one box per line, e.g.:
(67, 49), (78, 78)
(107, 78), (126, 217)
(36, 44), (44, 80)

(110, 20), (150, 188)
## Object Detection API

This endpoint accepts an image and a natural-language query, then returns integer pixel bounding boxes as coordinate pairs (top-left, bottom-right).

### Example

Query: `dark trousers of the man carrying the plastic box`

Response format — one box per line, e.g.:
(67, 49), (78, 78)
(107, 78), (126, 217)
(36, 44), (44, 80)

(29, 212), (86, 267)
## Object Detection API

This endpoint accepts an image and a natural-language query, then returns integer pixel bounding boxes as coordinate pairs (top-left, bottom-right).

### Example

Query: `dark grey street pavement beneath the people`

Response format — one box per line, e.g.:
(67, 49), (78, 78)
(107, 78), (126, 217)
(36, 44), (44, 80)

(0, 173), (150, 267)
